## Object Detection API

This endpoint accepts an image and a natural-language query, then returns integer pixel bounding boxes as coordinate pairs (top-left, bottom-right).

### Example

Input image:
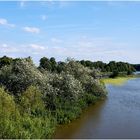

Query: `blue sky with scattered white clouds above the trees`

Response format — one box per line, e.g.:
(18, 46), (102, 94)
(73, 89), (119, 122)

(0, 0), (140, 64)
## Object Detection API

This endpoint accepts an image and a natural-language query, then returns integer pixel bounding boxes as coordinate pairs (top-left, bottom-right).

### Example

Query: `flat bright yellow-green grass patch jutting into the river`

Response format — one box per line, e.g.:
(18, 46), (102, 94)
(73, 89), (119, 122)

(101, 76), (135, 86)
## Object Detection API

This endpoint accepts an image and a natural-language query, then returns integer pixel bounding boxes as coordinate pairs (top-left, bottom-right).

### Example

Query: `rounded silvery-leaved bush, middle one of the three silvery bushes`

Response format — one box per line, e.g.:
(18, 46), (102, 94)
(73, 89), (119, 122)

(50, 72), (83, 100)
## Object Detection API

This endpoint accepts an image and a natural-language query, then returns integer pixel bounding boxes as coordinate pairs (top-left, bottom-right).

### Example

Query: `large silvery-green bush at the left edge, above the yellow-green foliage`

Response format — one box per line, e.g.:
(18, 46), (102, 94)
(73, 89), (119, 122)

(0, 59), (46, 95)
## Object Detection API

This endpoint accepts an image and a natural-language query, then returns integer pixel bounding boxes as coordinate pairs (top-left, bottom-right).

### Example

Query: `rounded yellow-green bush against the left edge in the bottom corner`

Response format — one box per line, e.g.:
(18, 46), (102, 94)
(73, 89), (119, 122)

(0, 88), (20, 139)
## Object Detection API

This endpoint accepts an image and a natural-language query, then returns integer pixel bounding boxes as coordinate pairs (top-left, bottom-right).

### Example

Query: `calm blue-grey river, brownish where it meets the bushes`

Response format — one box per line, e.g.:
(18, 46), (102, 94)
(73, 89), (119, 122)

(54, 78), (140, 139)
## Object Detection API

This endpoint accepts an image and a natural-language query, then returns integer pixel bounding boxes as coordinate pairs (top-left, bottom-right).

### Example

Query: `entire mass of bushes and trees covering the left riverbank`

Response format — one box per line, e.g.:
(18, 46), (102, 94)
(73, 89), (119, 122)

(0, 56), (135, 139)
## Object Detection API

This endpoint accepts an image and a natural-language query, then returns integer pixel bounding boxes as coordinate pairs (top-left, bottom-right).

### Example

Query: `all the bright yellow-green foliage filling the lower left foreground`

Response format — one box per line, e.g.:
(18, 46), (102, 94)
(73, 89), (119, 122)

(0, 87), (56, 139)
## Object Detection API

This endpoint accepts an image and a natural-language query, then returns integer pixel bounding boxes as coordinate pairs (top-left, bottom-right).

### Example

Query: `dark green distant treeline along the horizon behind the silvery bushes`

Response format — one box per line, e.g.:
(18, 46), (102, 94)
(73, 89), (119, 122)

(0, 56), (136, 74)
